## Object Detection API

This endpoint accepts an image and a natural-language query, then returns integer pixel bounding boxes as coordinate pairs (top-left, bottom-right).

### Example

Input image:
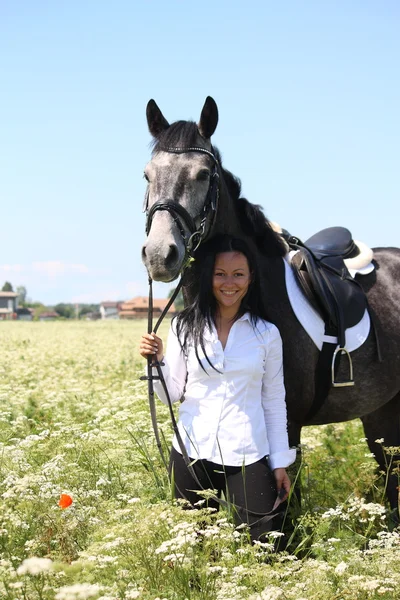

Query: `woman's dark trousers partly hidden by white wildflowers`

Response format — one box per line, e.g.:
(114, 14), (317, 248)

(169, 448), (277, 541)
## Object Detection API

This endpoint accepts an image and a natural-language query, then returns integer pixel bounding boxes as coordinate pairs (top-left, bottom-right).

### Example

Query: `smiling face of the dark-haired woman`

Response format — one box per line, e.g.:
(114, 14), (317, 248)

(213, 252), (251, 314)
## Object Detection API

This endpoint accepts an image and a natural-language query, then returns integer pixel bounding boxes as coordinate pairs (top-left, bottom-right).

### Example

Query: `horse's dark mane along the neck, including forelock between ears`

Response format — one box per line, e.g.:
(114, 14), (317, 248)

(153, 121), (287, 257)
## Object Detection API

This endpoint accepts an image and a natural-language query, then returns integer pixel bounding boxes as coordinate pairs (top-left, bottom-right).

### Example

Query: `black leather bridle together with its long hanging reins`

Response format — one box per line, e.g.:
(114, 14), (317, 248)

(140, 146), (279, 524)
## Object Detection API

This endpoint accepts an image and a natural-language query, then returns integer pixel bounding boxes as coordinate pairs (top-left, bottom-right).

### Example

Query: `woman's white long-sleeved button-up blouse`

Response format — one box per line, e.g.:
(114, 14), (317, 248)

(154, 313), (296, 469)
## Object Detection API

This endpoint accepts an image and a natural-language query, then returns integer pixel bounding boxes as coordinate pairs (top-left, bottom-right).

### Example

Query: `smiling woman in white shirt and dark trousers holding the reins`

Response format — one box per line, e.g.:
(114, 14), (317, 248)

(140, 236), (296, 540)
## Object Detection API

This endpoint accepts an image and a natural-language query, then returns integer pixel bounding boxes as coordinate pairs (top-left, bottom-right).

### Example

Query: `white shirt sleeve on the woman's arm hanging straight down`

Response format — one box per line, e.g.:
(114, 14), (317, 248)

(262, 325), (296, 470)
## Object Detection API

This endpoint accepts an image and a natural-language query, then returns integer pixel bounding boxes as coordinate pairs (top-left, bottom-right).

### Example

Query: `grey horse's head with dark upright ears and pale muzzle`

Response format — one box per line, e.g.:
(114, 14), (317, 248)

(142, 97), (218, 282)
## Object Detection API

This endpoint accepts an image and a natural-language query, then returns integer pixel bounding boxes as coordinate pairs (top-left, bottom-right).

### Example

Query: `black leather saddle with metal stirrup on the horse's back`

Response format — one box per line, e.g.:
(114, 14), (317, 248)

(282, 227), (367, 387)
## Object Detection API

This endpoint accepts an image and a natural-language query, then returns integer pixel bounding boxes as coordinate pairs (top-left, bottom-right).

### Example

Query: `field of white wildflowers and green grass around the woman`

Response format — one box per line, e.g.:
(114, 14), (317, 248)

(0, 321), (400, 600)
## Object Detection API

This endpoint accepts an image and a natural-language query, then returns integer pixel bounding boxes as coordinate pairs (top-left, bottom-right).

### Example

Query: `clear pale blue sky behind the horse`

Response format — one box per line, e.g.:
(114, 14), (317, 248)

(0, 0), (400, 304)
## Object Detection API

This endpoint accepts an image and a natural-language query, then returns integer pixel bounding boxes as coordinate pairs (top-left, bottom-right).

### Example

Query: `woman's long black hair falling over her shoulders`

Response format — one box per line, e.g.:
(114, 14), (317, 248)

(174, 235), (267, 369)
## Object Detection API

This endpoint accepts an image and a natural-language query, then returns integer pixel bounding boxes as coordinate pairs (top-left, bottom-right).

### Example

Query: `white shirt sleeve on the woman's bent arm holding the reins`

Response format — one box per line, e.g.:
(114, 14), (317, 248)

(153, 321), (187, 405)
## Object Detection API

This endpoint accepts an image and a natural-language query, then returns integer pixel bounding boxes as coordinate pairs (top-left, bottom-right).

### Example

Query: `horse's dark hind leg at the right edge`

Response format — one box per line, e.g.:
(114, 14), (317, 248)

(361, 392), (400, 510)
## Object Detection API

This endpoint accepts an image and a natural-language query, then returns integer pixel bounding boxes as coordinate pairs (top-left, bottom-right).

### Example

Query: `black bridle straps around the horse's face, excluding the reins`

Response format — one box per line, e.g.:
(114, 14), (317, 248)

(144, 146), (219, 256)
